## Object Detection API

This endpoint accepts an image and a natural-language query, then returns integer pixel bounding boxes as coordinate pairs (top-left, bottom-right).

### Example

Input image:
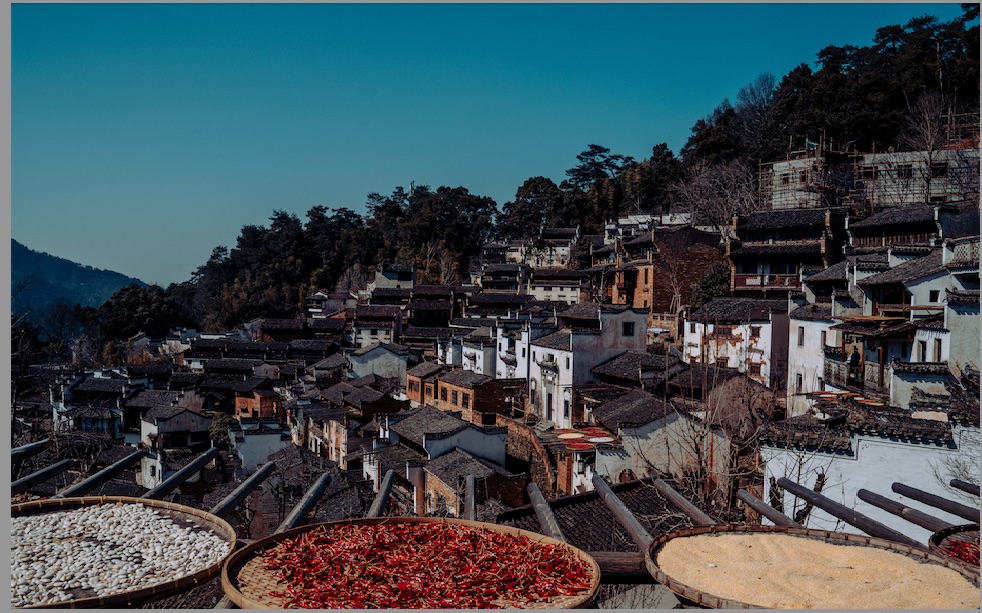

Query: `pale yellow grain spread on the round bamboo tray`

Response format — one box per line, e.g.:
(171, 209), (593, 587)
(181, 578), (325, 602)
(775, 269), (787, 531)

(655, 534), (979, 609)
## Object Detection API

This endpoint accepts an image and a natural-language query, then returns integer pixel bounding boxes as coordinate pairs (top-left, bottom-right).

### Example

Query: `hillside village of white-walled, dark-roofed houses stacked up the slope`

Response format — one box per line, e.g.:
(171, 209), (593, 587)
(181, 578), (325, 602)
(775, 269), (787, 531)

(12, 131), (980, 606)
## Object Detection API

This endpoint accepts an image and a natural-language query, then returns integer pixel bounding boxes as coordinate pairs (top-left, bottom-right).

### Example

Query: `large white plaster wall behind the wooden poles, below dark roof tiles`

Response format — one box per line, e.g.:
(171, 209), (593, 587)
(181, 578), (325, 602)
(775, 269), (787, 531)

(761, 429), (979, 545)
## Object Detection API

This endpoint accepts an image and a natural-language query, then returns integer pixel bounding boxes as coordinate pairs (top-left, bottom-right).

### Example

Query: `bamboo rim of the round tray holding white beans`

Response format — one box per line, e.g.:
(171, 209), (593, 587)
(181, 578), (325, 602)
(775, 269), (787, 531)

(10, 496), (236, 609)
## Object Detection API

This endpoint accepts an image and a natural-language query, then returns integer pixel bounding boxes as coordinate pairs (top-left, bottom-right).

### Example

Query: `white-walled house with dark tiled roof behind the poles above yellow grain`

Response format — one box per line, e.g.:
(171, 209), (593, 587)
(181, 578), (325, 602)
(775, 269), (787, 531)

(761, 394), (979, 543)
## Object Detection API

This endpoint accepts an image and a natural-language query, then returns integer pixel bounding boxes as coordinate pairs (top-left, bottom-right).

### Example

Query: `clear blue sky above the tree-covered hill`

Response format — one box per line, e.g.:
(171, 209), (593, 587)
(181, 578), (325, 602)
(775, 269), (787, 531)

(11, 3), (961, 286)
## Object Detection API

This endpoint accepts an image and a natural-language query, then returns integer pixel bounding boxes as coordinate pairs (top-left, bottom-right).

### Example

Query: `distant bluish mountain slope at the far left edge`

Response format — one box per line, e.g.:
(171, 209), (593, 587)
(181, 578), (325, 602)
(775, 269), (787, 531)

(10, 239), (147, 323)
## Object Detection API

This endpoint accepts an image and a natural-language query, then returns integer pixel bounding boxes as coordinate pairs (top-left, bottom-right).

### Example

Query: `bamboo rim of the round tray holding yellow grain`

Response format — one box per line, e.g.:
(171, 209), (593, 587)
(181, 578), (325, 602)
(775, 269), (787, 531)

(644, 524), (979, 609)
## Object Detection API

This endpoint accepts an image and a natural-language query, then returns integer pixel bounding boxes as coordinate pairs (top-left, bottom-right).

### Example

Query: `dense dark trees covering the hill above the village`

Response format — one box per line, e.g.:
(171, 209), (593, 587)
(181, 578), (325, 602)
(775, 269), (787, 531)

(11, 4), (979, 356)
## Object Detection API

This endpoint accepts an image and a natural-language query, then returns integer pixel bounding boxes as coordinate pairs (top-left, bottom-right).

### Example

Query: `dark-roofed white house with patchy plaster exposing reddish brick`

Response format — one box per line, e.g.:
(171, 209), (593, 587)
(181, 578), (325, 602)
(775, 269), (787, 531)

(682, 298), (789, 389)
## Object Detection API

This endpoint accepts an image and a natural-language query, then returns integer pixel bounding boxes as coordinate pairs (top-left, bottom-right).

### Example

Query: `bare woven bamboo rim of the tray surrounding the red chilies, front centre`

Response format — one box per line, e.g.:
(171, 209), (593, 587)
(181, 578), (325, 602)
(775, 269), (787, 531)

(222, 517), (600, 609)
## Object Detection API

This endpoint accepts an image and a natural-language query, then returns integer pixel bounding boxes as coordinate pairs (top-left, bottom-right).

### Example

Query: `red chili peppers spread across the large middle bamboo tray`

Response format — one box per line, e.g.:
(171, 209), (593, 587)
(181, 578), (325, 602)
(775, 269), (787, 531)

(262, 523), (592, 609)
